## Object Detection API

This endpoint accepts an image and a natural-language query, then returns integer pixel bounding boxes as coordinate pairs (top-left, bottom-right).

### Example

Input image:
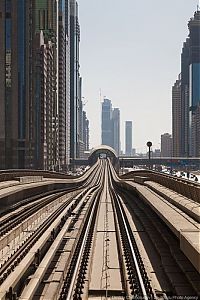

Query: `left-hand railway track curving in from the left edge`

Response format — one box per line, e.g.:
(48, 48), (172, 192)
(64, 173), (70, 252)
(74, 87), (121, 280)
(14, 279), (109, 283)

(0, 163), (103, 298)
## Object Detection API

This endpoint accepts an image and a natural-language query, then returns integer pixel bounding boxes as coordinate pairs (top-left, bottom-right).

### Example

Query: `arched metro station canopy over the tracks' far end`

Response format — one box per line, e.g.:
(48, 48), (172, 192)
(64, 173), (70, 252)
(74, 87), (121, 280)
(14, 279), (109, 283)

(88, 145), (118, 166)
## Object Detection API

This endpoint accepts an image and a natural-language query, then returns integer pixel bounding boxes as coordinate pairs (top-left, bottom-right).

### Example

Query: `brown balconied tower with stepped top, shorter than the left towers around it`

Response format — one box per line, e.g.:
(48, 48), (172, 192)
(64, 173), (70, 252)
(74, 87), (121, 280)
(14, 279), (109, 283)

(31, 31), (57, 170)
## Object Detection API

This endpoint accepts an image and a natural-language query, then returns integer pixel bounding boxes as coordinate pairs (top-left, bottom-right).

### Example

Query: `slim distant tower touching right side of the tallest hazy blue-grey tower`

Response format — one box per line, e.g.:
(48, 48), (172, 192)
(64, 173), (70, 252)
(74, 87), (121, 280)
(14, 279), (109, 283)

(112, 108), (120, 155)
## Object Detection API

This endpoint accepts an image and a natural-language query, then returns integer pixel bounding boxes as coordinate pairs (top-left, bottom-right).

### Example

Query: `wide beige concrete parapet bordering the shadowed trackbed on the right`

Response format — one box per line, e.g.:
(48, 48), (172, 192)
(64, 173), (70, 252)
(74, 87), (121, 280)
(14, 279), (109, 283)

(120, 181), (200, 272)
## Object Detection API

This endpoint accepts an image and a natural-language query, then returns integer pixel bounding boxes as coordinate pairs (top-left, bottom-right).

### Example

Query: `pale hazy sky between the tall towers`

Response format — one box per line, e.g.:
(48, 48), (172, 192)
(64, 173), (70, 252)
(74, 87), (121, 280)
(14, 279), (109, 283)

(78, 0), (198, 152)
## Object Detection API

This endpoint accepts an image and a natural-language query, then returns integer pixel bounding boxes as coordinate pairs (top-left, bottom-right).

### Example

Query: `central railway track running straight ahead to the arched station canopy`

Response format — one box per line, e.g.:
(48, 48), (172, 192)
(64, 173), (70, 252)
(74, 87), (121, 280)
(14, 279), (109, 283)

(59, 159), (155, 300)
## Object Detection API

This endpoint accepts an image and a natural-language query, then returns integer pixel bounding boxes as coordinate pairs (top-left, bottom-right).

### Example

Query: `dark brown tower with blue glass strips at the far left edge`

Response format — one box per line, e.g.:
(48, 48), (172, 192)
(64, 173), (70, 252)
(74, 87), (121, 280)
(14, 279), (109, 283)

(0, 0), (33, 169)
